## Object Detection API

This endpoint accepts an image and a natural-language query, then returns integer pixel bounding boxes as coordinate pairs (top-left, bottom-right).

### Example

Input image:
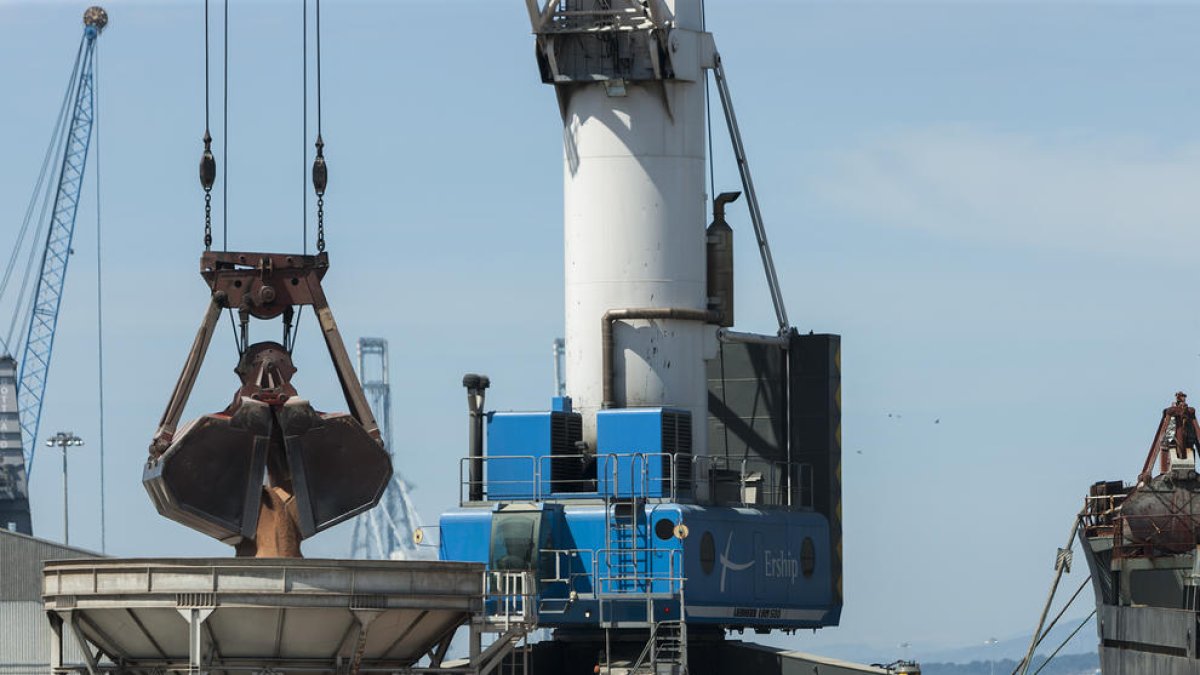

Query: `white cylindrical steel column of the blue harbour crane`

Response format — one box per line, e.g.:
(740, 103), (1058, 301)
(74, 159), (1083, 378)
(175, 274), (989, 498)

(559, 0), (708, 454)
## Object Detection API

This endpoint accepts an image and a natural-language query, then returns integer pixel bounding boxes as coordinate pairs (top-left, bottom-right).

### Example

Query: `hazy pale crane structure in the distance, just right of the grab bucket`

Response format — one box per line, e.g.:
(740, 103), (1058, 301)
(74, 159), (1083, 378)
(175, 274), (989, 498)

(350, 338), (434, 560)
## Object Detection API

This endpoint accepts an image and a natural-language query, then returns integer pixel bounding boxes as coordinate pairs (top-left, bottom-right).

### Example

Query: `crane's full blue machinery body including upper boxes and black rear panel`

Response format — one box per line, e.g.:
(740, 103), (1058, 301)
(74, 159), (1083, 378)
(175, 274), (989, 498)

(439, 330), (842, 631)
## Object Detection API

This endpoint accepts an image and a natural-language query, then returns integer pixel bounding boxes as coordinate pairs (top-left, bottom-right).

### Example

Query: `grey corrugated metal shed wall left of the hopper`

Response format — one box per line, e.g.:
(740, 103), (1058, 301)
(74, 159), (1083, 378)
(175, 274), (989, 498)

(0, 530), (98, 675)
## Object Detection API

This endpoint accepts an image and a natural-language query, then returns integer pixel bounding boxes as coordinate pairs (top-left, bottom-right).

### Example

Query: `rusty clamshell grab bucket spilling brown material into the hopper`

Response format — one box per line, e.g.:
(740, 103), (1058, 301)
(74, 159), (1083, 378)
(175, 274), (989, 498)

(143, 252), (392, 557)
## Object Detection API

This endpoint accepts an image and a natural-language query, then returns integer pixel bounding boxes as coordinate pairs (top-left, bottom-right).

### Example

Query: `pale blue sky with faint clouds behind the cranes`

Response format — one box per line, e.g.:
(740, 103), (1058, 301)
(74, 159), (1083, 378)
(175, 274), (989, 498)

(0, 0), (1200, 656)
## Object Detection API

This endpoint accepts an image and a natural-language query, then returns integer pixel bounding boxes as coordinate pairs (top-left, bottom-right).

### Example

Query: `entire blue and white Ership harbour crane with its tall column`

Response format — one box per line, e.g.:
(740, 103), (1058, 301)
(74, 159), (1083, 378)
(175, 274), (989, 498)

(439, 0), (842, 673)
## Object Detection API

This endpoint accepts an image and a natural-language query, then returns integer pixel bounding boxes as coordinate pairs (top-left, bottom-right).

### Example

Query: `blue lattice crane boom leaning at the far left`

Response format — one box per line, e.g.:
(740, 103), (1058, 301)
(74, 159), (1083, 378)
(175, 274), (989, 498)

(0, 7), (108, 533)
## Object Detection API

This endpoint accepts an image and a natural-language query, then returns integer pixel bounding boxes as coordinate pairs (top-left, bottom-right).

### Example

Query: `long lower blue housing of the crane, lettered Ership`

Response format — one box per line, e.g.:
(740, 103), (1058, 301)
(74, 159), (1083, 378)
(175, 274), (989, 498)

(440, 502), (841, 629)
